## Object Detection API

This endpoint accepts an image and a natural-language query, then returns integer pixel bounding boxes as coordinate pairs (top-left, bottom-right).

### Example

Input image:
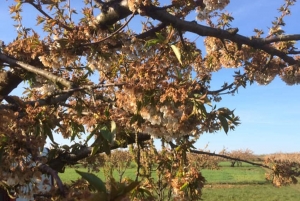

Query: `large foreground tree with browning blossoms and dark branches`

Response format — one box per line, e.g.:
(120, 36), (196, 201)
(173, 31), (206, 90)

(0, 0), (300, 200)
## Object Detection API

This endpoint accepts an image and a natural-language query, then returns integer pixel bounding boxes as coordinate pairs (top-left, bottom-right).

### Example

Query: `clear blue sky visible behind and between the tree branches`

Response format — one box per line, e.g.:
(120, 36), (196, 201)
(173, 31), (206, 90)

(0, 0), (300, 154)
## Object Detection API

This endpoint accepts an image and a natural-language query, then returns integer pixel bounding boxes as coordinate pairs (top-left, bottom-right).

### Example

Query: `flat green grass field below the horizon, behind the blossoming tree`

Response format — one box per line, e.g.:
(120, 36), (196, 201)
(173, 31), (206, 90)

(60, 162), (300, 201)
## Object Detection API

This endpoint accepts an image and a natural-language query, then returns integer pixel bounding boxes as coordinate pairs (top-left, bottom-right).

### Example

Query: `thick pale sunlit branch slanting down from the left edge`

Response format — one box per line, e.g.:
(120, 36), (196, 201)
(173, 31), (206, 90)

(0, 53), (73, 88)
